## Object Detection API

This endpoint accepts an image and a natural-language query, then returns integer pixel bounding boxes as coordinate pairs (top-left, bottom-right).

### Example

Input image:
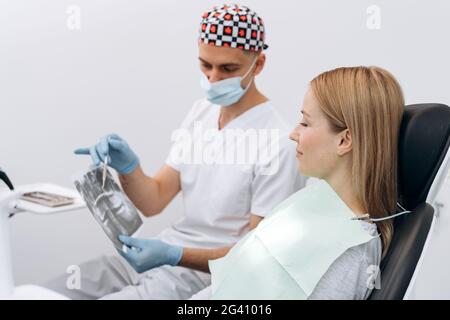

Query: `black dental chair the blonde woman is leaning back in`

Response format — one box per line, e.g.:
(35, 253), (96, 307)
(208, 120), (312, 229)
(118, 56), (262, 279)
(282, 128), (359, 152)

(369, 104), (450, 300)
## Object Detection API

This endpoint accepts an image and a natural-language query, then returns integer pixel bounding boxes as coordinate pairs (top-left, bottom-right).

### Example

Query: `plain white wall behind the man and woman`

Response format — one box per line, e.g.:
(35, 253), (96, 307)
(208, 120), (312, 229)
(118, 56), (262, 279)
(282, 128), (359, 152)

(0, 0), (450, 290)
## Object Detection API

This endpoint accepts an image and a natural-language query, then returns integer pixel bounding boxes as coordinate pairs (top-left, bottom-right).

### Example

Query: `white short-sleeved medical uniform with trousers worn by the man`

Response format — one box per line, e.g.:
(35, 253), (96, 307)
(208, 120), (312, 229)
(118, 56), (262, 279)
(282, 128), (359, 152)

(45, 99), (305, 299)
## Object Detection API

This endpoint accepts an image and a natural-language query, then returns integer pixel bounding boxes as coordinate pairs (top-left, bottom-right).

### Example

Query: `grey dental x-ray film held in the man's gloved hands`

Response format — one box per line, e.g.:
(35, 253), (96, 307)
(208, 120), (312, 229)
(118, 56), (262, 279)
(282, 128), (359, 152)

(73, 167), (142, 250)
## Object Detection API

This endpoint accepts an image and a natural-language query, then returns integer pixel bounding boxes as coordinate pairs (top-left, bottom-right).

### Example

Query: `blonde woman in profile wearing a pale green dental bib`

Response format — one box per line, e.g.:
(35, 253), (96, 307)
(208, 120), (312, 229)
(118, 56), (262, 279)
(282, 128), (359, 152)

(192, 67), (404, 299)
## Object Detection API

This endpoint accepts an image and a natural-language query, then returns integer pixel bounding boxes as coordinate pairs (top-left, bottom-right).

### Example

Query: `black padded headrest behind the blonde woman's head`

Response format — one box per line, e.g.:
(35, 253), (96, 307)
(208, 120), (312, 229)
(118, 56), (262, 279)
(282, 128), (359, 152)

(398, 103), (450, 210)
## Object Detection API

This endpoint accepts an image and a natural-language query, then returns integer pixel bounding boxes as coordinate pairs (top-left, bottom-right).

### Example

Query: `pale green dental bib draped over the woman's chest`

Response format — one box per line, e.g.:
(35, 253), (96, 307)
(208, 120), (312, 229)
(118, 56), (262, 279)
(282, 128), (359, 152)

(209, 180), (374, 300)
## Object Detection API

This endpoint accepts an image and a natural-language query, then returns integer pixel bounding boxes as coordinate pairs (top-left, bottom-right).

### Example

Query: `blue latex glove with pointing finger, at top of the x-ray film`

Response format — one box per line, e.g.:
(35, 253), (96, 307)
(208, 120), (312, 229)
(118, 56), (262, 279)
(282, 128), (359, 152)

(75, 134), (139, 174)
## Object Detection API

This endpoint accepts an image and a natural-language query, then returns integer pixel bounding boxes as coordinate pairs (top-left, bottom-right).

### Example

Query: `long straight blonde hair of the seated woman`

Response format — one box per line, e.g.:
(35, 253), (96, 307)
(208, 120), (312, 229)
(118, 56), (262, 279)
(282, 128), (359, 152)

(311, 67), (405, 257)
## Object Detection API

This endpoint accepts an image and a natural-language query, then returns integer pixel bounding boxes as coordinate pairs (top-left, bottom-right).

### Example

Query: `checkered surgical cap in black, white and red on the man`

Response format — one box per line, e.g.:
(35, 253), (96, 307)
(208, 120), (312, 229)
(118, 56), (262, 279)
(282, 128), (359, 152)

(199, 4), (268, 51)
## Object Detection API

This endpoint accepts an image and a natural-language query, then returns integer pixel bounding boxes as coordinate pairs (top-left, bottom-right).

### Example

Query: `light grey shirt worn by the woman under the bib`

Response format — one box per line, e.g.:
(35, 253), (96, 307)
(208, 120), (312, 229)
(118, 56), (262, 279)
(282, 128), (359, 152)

(308, 221), (382, 300)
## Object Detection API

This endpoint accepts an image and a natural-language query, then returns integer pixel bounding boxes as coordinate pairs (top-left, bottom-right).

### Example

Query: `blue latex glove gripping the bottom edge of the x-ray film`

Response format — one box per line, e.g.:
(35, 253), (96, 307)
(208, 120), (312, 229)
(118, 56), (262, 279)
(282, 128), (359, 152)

(118, 235), (183, 273)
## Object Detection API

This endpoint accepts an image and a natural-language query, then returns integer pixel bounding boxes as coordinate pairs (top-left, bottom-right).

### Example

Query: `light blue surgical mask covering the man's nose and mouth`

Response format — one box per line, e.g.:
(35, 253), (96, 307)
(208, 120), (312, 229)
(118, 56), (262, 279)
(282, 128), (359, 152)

(200, 57), (258, 107)
